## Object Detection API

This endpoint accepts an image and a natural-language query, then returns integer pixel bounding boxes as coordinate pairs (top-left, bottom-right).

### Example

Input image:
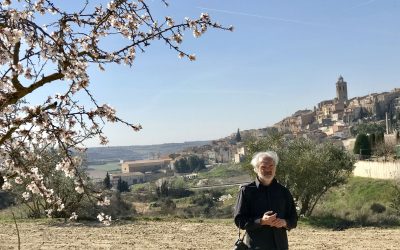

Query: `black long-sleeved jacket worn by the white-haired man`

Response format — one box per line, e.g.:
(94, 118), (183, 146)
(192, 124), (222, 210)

(234, 179), (297, 250)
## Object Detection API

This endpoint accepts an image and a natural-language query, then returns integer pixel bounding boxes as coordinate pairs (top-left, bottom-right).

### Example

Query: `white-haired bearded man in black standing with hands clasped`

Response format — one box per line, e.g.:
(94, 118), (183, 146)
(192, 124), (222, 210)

(234, 151), (297, 250)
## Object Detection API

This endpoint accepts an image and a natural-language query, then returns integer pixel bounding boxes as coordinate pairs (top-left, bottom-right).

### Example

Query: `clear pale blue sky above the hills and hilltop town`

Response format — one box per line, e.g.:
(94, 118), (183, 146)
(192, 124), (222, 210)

(29, 0), (400, 147)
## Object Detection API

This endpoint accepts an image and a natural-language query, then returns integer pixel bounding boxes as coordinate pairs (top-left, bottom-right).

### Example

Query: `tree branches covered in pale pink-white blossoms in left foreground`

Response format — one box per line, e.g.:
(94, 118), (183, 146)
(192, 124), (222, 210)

(0, 0), (232, 221)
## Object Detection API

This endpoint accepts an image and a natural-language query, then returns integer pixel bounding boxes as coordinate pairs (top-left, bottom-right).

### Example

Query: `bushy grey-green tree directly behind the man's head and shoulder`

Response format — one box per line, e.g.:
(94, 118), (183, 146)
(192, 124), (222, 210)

(245, 134), (354, 216)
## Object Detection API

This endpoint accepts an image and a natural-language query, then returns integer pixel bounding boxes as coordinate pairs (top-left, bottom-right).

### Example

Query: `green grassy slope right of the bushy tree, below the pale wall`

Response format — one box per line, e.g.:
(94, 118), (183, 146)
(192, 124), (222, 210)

(312, 177), (400, 228)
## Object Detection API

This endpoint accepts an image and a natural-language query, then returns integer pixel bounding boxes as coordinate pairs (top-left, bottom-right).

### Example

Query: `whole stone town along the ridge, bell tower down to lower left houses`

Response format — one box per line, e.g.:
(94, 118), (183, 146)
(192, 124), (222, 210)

(180, 76), (400, 163)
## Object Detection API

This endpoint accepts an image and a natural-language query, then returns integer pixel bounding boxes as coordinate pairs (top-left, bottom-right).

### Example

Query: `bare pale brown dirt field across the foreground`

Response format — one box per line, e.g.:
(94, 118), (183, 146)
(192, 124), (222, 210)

(0, 221), (400, 250)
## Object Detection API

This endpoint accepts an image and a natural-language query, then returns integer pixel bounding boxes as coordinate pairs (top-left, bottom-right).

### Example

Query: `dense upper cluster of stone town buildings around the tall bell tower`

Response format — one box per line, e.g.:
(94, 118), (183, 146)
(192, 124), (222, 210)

(274, 76), (400, 139)
